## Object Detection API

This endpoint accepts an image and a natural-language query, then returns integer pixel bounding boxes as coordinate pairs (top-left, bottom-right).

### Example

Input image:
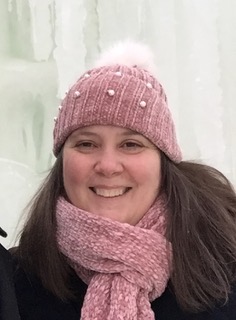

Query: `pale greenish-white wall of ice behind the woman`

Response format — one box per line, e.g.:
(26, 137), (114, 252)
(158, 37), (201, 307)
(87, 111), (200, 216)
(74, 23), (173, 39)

(0, 0), (236, 247)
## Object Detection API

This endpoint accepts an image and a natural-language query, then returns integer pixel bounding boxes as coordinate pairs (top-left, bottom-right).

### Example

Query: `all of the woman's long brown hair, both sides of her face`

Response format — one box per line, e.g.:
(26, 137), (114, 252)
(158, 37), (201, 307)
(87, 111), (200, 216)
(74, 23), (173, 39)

(17, 154), (236, 312)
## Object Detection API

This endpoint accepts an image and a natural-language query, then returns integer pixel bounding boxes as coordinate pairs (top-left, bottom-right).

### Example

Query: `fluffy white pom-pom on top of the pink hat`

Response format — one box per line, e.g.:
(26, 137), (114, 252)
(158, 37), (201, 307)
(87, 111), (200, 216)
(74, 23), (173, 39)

(95, 40), (156, 74)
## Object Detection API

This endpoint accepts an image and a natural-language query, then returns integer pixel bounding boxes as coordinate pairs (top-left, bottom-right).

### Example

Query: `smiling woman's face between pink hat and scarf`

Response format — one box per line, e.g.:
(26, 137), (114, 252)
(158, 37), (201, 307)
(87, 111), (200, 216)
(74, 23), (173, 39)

(63, 125), (161, 225)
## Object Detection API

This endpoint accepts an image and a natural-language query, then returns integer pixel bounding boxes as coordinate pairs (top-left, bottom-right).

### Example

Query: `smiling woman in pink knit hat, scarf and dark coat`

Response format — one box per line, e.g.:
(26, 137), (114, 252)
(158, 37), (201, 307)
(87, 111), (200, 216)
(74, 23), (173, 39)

(14, 43), (236, 320)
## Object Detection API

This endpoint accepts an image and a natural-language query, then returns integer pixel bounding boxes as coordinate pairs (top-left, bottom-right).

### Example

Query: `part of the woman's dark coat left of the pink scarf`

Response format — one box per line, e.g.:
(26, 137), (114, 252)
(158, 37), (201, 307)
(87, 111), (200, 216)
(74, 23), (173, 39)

(11, 251), (86, 320)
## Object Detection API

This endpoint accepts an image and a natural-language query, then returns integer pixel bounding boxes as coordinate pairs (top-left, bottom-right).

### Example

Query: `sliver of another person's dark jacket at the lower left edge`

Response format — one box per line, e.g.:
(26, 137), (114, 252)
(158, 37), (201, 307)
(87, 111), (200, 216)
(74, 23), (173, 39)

(0, 244), (20, 320)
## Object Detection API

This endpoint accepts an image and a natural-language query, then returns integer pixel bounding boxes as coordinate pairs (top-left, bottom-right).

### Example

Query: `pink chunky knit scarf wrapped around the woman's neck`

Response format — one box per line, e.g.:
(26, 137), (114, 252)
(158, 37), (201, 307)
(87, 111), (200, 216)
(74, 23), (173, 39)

(57, 197), (172, 320)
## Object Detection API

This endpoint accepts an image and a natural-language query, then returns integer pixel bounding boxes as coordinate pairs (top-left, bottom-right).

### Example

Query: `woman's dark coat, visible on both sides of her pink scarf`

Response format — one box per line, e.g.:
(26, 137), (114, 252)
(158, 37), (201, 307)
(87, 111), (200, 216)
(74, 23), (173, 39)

(14, 255), (236, 320)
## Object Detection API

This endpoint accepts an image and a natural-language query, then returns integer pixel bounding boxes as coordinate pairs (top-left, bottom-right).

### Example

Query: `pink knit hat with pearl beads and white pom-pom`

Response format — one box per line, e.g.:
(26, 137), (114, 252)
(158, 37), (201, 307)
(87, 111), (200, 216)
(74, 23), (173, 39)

(53, 42), (182, 162)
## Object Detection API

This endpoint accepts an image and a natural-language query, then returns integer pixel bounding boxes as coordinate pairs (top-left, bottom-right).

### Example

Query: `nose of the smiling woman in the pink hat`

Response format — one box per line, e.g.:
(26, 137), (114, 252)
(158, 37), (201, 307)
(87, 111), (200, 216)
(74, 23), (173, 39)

(94, 150), (124, 177)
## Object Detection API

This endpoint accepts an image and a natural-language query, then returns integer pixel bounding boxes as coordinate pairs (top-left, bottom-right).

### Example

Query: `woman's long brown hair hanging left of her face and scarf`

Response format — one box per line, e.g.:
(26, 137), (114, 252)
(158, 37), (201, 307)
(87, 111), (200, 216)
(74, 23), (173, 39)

(16, 153), (74, 300)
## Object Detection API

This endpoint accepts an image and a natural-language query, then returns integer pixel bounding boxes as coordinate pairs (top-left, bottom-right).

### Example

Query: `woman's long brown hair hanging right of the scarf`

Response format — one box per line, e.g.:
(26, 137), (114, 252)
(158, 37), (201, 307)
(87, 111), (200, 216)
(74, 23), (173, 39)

(162, 155), (236, 312)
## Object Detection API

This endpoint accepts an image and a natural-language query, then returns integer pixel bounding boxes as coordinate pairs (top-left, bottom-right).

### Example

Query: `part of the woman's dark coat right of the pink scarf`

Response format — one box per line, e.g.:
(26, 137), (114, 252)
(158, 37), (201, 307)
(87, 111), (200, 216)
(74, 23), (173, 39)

(152, 284), (236, 320)
